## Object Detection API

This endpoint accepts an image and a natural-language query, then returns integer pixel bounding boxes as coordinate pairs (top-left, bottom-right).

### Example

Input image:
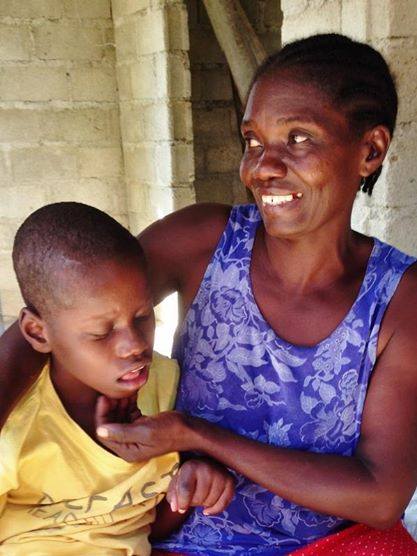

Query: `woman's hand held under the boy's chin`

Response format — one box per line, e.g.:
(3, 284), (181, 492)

(95, 396), (188, 462)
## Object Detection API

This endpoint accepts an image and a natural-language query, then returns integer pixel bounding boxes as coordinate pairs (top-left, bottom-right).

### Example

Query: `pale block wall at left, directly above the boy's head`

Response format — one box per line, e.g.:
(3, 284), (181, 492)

(0, 0), (127, 327)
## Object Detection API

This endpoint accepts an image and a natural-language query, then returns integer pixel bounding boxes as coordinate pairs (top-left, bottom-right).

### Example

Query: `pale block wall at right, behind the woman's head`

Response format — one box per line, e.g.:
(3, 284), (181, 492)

(281, 0), (417, 255)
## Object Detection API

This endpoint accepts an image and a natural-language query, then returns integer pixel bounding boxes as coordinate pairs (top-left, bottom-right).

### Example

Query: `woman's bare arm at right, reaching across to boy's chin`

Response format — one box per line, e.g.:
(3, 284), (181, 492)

(96, 271), (417, 528)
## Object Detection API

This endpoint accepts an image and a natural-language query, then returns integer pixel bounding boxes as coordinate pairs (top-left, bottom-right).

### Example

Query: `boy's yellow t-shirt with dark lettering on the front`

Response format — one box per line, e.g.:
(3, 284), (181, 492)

(0, 354), (179, 556)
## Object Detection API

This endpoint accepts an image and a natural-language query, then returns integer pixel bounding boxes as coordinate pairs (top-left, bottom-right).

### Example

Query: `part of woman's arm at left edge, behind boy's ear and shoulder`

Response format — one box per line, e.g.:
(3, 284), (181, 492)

(0, 322), (46, 427)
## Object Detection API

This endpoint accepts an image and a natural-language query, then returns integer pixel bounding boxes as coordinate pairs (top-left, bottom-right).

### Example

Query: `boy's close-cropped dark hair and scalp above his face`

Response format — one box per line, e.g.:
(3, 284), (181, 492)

(13, 202), (145, 315)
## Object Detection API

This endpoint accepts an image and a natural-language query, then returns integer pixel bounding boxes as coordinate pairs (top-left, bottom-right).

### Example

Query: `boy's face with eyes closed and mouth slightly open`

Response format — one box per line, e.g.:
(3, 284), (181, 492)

(40, 261), (155, 398)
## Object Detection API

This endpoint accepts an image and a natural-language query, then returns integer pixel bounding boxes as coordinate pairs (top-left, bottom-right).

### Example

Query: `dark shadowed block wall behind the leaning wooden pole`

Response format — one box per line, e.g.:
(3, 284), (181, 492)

(187, 0), (282, 204)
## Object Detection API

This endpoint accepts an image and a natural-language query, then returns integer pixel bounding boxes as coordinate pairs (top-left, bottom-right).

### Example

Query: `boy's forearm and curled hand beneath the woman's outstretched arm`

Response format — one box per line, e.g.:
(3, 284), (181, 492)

(151, 458), (235, 539)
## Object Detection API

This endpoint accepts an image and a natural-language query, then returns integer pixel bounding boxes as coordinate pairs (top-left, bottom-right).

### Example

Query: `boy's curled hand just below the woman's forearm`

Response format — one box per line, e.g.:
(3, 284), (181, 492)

(167, 459), (235, 515)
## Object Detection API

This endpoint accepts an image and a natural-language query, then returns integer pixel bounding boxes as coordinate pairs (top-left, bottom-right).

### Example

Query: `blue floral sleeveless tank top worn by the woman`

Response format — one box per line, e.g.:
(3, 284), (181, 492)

(158, 205), (415, 556)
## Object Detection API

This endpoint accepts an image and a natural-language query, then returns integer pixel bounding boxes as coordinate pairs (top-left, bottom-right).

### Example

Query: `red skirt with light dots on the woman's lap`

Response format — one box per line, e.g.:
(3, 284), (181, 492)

(291, 522), (417, 556)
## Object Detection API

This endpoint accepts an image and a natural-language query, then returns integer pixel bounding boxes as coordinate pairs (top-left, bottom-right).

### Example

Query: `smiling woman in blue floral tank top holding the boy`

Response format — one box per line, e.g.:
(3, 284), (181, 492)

(2, 35), (417, 555)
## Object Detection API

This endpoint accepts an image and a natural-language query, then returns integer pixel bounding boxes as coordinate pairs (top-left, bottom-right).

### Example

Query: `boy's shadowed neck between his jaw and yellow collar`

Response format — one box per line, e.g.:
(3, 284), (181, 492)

(50, 359), (99, 437)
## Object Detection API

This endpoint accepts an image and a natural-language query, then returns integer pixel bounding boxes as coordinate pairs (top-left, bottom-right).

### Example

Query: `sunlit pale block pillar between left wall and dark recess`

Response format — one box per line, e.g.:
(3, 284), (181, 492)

(112, 0), (195, 233)
